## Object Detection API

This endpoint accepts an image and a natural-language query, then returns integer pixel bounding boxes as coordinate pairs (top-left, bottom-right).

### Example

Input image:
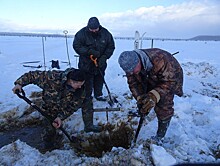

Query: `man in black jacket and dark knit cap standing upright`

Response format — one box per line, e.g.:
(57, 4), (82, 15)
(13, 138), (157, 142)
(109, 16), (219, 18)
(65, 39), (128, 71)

(73, 17), (115, 101)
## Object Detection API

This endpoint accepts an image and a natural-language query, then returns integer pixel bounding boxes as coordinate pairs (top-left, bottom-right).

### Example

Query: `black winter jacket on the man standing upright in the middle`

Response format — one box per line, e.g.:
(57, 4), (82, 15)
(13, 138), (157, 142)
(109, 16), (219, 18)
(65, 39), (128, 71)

(73, 26), (115, 73)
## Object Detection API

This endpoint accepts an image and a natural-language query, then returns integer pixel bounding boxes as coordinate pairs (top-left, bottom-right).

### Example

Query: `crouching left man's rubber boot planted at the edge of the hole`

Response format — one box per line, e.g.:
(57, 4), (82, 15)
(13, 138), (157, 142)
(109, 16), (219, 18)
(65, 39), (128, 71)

(82, 111), (102, 133)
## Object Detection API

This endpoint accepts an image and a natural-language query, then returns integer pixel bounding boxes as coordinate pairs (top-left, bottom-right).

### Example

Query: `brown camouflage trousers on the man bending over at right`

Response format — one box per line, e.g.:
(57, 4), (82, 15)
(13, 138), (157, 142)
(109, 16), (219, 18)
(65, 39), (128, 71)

(154, 93), (174, 120)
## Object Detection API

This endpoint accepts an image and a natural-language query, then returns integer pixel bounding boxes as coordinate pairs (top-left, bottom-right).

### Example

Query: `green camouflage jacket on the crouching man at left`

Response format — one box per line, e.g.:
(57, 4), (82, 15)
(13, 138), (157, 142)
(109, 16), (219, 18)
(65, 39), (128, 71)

(15, 68), (89, 119)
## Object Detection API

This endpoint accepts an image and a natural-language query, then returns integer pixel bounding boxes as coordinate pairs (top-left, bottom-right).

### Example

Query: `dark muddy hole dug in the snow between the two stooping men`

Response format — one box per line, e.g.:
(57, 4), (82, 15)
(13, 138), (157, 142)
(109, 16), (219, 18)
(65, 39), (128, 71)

(71, 122), (134, 157)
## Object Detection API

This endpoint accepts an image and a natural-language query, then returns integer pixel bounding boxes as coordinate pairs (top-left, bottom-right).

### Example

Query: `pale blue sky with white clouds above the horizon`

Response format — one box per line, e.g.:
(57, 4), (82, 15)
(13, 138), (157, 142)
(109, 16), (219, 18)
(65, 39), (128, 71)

(0, 0), (220, 38)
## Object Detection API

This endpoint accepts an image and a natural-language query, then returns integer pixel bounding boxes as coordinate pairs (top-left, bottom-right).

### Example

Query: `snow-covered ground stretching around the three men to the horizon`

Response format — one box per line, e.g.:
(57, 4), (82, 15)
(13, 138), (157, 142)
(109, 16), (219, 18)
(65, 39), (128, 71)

(0, 36), (220, 166)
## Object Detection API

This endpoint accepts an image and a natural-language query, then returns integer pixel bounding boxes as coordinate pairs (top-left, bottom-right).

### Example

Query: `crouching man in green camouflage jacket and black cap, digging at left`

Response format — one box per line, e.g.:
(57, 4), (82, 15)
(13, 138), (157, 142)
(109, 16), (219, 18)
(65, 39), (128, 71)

(12, 68), (101, 148)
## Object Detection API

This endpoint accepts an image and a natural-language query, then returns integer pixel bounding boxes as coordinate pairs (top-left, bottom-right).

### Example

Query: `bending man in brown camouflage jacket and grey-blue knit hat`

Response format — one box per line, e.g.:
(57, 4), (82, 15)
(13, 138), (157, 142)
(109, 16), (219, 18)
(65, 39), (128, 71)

(118, 48), (183, 141)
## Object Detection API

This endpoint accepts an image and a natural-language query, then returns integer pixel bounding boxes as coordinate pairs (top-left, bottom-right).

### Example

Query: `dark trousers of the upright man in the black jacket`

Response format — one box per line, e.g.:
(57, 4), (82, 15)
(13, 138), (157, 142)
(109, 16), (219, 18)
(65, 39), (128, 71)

(85, 71), (105, 98)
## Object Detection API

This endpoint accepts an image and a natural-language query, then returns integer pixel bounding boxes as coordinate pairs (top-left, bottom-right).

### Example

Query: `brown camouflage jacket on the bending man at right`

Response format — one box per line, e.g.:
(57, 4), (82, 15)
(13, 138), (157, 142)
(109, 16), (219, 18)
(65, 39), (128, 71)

(127, 48), (183, 99)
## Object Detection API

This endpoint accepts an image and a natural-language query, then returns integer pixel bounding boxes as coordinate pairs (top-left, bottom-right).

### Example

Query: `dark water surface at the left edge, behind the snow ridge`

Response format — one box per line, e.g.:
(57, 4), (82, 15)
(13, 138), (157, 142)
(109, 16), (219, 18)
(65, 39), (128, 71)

(0, 124), (45, 152)
